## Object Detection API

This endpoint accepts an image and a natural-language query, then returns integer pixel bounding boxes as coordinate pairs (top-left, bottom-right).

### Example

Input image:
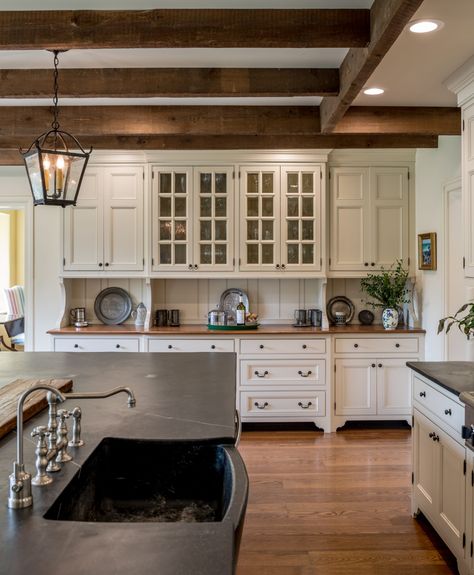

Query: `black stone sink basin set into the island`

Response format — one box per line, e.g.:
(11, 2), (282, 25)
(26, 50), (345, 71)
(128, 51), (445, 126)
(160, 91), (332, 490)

(44, 437), (235, 523)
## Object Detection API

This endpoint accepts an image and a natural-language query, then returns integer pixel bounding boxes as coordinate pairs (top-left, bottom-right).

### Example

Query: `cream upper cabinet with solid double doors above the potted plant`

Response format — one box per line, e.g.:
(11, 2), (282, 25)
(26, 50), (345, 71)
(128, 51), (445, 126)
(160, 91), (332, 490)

(329, 166), (409, 272)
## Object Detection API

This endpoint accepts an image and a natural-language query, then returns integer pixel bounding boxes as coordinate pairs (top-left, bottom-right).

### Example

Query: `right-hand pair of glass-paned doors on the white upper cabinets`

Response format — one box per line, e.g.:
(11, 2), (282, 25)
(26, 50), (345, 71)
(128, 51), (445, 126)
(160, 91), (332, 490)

(239, 165), (322, 273)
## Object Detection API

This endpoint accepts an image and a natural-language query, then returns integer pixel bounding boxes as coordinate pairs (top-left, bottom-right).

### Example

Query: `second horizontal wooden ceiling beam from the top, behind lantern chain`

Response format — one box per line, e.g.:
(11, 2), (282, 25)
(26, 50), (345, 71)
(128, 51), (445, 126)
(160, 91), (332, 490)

(0, 68), (339, 100)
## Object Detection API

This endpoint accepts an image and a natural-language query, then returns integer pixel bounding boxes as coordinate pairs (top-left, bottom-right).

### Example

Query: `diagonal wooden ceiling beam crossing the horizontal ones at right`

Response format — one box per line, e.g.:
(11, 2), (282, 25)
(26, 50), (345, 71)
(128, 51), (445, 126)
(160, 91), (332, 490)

(321, 0), (423, 133)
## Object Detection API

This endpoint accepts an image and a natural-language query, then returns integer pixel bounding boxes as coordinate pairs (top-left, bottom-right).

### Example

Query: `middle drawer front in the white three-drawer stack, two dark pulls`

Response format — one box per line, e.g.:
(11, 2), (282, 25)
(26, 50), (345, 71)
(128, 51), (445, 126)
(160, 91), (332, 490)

(240, 359), (326, 387)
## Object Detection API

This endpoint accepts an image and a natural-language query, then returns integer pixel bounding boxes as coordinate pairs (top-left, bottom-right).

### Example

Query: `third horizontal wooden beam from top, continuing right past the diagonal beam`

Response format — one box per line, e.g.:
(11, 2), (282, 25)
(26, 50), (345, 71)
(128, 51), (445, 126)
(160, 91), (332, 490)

(0, 106), (461, 139)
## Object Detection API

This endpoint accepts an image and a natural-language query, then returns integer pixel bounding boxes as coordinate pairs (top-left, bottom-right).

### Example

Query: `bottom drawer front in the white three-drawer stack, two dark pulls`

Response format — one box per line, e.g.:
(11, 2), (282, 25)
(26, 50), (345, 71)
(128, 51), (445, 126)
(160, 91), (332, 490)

(240, 391), (326, 418)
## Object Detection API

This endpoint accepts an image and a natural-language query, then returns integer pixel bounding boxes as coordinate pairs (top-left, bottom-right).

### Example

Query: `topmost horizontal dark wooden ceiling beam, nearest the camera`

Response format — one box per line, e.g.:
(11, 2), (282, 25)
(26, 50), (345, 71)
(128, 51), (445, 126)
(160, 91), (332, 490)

(0, 9), (370, 50)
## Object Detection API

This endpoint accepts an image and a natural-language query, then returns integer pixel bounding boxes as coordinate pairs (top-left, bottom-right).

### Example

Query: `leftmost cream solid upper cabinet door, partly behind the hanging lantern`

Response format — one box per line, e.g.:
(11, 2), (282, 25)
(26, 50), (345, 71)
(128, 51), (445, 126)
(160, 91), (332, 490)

(64, 168), (103, 271)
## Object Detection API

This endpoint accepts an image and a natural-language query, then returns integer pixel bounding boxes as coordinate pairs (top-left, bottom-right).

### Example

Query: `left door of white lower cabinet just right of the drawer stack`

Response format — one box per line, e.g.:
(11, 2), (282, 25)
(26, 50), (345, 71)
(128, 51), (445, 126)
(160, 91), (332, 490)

(336, 359), (377, 415)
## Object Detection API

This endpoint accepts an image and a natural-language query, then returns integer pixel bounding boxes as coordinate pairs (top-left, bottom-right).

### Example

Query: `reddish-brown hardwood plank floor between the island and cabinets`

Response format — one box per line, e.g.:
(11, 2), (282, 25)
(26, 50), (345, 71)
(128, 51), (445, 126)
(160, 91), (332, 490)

(237, 429), (457, 575)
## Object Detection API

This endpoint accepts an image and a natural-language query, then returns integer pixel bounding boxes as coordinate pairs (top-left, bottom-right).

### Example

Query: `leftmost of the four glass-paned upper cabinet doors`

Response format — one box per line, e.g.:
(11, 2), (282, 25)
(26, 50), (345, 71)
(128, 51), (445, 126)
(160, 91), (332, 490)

(152, 166), (193, 271)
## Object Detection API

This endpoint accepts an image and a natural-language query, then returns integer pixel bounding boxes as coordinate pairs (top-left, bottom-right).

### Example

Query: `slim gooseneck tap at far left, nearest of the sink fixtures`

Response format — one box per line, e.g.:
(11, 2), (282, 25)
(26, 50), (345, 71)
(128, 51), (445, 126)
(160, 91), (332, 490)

(7, 383), (66, 509)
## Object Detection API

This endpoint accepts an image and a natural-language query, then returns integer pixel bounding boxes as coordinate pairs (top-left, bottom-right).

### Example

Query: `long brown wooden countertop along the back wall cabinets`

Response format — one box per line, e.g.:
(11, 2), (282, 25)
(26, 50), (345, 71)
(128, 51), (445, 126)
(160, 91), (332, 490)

(48, 324), (425, 336)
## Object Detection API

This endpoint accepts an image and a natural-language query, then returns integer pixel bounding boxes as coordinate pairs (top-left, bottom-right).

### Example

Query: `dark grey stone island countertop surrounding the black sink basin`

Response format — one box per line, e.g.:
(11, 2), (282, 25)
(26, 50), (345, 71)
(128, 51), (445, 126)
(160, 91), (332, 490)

(0, 352), (247, 575)
